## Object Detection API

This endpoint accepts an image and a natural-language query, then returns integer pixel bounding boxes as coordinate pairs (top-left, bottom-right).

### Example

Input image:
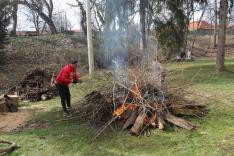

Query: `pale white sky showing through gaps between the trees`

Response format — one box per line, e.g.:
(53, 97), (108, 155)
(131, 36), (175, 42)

(17, 0), (210, 31)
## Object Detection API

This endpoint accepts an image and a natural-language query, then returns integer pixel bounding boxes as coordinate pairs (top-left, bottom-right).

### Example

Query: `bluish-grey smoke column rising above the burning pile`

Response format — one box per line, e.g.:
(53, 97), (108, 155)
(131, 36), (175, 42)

(101, 0), (136, 69)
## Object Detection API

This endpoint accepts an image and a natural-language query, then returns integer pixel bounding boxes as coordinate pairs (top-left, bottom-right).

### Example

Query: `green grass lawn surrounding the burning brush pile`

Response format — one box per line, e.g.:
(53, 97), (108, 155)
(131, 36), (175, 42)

(0, 60), (234, 156)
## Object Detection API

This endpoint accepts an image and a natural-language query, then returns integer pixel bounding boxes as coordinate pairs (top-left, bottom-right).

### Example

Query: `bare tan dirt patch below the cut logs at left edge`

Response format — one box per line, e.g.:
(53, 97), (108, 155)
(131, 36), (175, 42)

(0, 110), (29, 132)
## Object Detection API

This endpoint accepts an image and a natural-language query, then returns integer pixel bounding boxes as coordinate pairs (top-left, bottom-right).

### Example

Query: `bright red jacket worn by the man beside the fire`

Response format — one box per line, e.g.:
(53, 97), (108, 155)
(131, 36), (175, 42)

(56, 64), (78, 85)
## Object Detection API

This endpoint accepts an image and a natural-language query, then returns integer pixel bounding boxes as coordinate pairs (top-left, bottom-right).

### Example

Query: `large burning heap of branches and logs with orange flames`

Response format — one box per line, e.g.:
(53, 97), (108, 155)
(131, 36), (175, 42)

(78, 64), (207, 135)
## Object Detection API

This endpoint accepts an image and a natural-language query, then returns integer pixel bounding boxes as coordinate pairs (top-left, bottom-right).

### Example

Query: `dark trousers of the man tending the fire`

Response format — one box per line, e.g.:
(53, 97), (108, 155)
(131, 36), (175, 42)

(56, 84), (71, 112)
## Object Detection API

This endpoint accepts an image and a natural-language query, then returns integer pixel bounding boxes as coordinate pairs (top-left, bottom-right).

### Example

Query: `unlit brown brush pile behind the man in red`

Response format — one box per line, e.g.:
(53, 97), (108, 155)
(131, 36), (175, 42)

(9, 67), (57, 101)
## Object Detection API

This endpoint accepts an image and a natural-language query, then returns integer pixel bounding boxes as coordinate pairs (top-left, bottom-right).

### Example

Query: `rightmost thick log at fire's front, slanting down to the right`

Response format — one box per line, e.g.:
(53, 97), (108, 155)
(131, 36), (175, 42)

(165, 113), (195, 130)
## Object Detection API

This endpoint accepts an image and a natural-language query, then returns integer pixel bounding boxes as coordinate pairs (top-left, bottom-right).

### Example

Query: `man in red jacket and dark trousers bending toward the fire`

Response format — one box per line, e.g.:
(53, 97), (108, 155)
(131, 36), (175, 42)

(55, 61), (79, 116)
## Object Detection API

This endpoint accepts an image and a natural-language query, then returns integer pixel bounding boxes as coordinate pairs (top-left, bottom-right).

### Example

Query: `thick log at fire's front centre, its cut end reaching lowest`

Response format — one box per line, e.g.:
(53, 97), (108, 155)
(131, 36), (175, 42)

(130, 110), (146, 135)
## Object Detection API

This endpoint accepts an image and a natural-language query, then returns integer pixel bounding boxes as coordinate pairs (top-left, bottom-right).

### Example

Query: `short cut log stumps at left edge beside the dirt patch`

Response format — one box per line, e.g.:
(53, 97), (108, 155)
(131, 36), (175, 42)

(0, 94), (19, 112)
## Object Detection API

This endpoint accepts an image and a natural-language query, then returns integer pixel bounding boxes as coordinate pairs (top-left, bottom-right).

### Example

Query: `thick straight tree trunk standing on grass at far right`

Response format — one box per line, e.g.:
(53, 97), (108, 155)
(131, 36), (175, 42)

(216, 0), (228, 71)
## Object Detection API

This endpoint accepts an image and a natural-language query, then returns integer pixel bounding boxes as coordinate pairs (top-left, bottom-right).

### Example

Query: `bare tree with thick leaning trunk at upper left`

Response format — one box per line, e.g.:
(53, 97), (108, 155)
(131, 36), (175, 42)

(20, 0), (57, 34)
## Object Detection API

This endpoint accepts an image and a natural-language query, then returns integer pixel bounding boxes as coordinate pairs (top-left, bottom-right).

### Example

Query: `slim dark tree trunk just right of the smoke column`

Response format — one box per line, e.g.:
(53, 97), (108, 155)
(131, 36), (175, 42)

(140, 0), (146, 52)
